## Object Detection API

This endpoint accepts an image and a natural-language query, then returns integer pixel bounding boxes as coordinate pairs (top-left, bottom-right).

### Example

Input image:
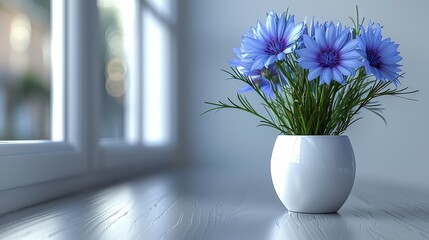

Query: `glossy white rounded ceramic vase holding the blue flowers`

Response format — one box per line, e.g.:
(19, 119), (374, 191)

(271, 135), (356, 213)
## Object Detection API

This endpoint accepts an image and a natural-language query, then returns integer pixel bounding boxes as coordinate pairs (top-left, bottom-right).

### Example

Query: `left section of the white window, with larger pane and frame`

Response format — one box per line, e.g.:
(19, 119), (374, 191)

(0, 0), (87, 194)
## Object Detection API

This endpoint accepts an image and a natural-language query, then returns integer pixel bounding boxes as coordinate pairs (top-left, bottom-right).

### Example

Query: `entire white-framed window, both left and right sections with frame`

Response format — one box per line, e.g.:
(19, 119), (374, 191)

(0, 0), (176, 212)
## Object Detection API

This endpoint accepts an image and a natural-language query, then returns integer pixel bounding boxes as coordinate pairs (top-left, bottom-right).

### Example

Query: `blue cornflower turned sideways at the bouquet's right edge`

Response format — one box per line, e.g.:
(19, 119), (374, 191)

(357, 23), (402, 85)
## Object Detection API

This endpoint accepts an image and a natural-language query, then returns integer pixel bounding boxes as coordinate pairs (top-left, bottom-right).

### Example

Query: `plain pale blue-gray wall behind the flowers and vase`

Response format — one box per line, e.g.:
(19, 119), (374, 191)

(179, 0), (429, 188)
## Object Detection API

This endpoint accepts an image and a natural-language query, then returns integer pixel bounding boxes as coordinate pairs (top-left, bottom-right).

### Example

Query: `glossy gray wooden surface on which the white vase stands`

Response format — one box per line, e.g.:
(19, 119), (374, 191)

(0, 168), (429, 240)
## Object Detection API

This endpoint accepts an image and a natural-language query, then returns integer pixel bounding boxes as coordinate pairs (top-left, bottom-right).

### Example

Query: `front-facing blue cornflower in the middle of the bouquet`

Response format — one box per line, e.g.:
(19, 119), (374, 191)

(296, 22), (362, 84)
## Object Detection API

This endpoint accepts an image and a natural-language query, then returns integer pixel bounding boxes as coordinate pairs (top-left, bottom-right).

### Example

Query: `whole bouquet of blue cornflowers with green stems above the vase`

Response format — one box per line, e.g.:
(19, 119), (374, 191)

(206, 8), (416, 135)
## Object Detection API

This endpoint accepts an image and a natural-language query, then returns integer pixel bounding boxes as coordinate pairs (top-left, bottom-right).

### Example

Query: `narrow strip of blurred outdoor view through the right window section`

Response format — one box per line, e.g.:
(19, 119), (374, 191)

(98, 0), (128, 138)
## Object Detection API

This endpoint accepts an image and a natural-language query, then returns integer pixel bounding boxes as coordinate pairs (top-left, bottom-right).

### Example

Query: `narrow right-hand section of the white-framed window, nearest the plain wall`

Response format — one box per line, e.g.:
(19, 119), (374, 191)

(97, 0), (176, 169)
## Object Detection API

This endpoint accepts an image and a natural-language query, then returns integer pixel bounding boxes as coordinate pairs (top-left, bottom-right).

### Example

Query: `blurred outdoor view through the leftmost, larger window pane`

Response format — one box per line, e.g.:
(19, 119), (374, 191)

(0, 0), (51, 140)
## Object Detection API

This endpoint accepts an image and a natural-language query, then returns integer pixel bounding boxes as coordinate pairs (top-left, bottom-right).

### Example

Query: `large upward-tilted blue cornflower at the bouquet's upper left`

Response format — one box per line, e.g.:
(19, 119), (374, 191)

(238, 11), (303, 70)
